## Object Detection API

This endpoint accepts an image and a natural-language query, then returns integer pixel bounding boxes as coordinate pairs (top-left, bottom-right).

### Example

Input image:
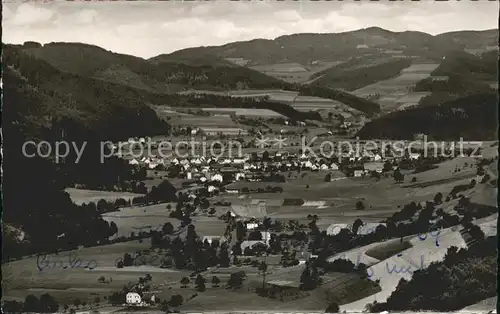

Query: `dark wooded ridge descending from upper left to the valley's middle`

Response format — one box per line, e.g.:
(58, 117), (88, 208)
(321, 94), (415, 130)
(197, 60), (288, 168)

(16, 42), (380, 115)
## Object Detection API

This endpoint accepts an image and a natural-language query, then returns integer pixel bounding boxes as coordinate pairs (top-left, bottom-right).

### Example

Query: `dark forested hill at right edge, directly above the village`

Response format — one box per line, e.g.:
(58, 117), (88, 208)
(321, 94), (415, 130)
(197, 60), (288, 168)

(357, 93), (498, 140)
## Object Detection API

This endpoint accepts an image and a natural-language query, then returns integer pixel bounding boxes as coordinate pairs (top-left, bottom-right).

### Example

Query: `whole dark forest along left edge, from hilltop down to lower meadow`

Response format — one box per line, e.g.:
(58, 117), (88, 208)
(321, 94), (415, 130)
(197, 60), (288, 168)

(2, 47), (174, 256)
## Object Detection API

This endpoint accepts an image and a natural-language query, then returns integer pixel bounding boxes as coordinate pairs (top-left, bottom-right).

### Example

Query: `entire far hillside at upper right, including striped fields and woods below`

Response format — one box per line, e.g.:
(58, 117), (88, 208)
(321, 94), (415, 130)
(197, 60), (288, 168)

(150, 27), (498, 112)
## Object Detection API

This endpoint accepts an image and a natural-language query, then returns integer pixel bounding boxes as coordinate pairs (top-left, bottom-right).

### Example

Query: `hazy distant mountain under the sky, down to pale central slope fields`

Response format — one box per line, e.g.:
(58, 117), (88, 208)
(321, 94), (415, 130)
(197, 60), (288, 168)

(155, 27), (498, 83)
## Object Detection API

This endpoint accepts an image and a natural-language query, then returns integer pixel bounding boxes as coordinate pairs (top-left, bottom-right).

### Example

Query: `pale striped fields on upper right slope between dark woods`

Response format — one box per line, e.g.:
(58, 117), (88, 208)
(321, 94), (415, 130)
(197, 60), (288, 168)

(353, 63), (439, 111)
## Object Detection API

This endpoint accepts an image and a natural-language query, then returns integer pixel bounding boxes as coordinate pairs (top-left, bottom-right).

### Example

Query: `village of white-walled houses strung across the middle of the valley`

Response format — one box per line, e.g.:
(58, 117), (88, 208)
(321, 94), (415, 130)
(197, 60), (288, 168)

(115, 138), (436, 182)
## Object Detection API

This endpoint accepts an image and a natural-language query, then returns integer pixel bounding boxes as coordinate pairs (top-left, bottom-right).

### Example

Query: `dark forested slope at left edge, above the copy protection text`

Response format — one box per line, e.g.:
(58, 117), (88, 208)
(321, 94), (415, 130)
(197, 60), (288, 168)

(3, 46), (169, 140)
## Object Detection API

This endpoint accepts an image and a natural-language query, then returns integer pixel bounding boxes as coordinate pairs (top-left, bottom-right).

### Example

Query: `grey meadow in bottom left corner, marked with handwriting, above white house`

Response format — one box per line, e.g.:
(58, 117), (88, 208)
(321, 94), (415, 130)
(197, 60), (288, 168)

(2, 241), (195, 303)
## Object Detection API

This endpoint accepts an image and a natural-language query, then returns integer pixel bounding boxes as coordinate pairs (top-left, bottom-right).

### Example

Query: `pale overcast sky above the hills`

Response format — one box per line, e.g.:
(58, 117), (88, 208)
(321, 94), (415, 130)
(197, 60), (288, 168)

(2, 0), (499, 58)
